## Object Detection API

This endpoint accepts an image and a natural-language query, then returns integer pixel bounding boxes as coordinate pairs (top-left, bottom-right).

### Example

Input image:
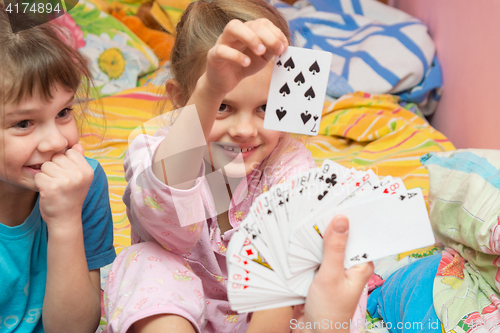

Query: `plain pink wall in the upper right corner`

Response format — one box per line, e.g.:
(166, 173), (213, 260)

(390, 0), (500, 149)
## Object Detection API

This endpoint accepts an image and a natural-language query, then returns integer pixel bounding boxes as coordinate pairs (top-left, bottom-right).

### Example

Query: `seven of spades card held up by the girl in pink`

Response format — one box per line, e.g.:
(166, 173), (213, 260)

(264, 46), (332, 135)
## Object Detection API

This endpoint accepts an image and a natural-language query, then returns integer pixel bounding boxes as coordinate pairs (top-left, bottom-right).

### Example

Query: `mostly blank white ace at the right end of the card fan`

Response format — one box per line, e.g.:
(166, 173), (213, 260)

(319, 188), (435, 268)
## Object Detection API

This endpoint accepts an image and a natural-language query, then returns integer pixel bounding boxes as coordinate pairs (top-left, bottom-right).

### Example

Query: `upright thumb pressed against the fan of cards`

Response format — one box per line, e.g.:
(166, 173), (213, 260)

(318, 215), (349, 278)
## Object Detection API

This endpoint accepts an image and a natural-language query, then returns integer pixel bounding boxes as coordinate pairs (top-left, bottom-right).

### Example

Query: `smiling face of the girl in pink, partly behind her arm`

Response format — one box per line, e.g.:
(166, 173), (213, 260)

(208, 61), (281, 176)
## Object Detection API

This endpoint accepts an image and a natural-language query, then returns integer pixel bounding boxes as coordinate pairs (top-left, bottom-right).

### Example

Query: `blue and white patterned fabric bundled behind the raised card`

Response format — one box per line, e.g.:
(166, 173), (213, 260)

(277, 0), (442, 114)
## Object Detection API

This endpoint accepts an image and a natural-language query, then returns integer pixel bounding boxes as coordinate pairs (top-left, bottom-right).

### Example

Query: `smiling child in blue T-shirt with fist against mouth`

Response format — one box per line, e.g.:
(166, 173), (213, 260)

(0, 4), (115, 332)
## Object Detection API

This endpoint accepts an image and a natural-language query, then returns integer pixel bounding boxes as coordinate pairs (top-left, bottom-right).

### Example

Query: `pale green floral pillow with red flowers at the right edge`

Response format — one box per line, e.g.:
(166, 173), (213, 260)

(421, 149), (500, 333)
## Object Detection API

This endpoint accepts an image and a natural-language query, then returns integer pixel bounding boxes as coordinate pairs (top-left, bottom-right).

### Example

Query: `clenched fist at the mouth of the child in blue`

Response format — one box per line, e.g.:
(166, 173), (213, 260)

(35, 144), (94, 229)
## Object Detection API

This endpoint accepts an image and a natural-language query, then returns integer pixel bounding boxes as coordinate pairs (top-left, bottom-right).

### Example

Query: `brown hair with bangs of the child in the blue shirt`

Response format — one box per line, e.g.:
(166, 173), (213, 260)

(0, 2), (92, 130)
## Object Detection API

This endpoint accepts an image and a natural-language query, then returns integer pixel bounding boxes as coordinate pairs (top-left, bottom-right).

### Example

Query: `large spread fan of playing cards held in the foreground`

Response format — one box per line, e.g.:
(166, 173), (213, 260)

(227, 160), (435, 312)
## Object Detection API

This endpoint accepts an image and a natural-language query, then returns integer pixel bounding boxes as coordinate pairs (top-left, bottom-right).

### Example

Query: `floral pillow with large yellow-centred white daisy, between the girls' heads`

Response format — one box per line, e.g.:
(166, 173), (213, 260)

(69, 0), (158, 97)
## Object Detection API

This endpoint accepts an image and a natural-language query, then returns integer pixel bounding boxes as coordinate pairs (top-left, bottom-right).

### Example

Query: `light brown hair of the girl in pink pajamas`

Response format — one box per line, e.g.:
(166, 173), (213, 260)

(170, 0), (300, 169)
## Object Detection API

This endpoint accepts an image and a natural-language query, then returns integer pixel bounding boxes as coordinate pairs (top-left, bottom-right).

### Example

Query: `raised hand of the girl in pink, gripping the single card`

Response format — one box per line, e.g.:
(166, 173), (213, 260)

(204, 19), (288, 95)
